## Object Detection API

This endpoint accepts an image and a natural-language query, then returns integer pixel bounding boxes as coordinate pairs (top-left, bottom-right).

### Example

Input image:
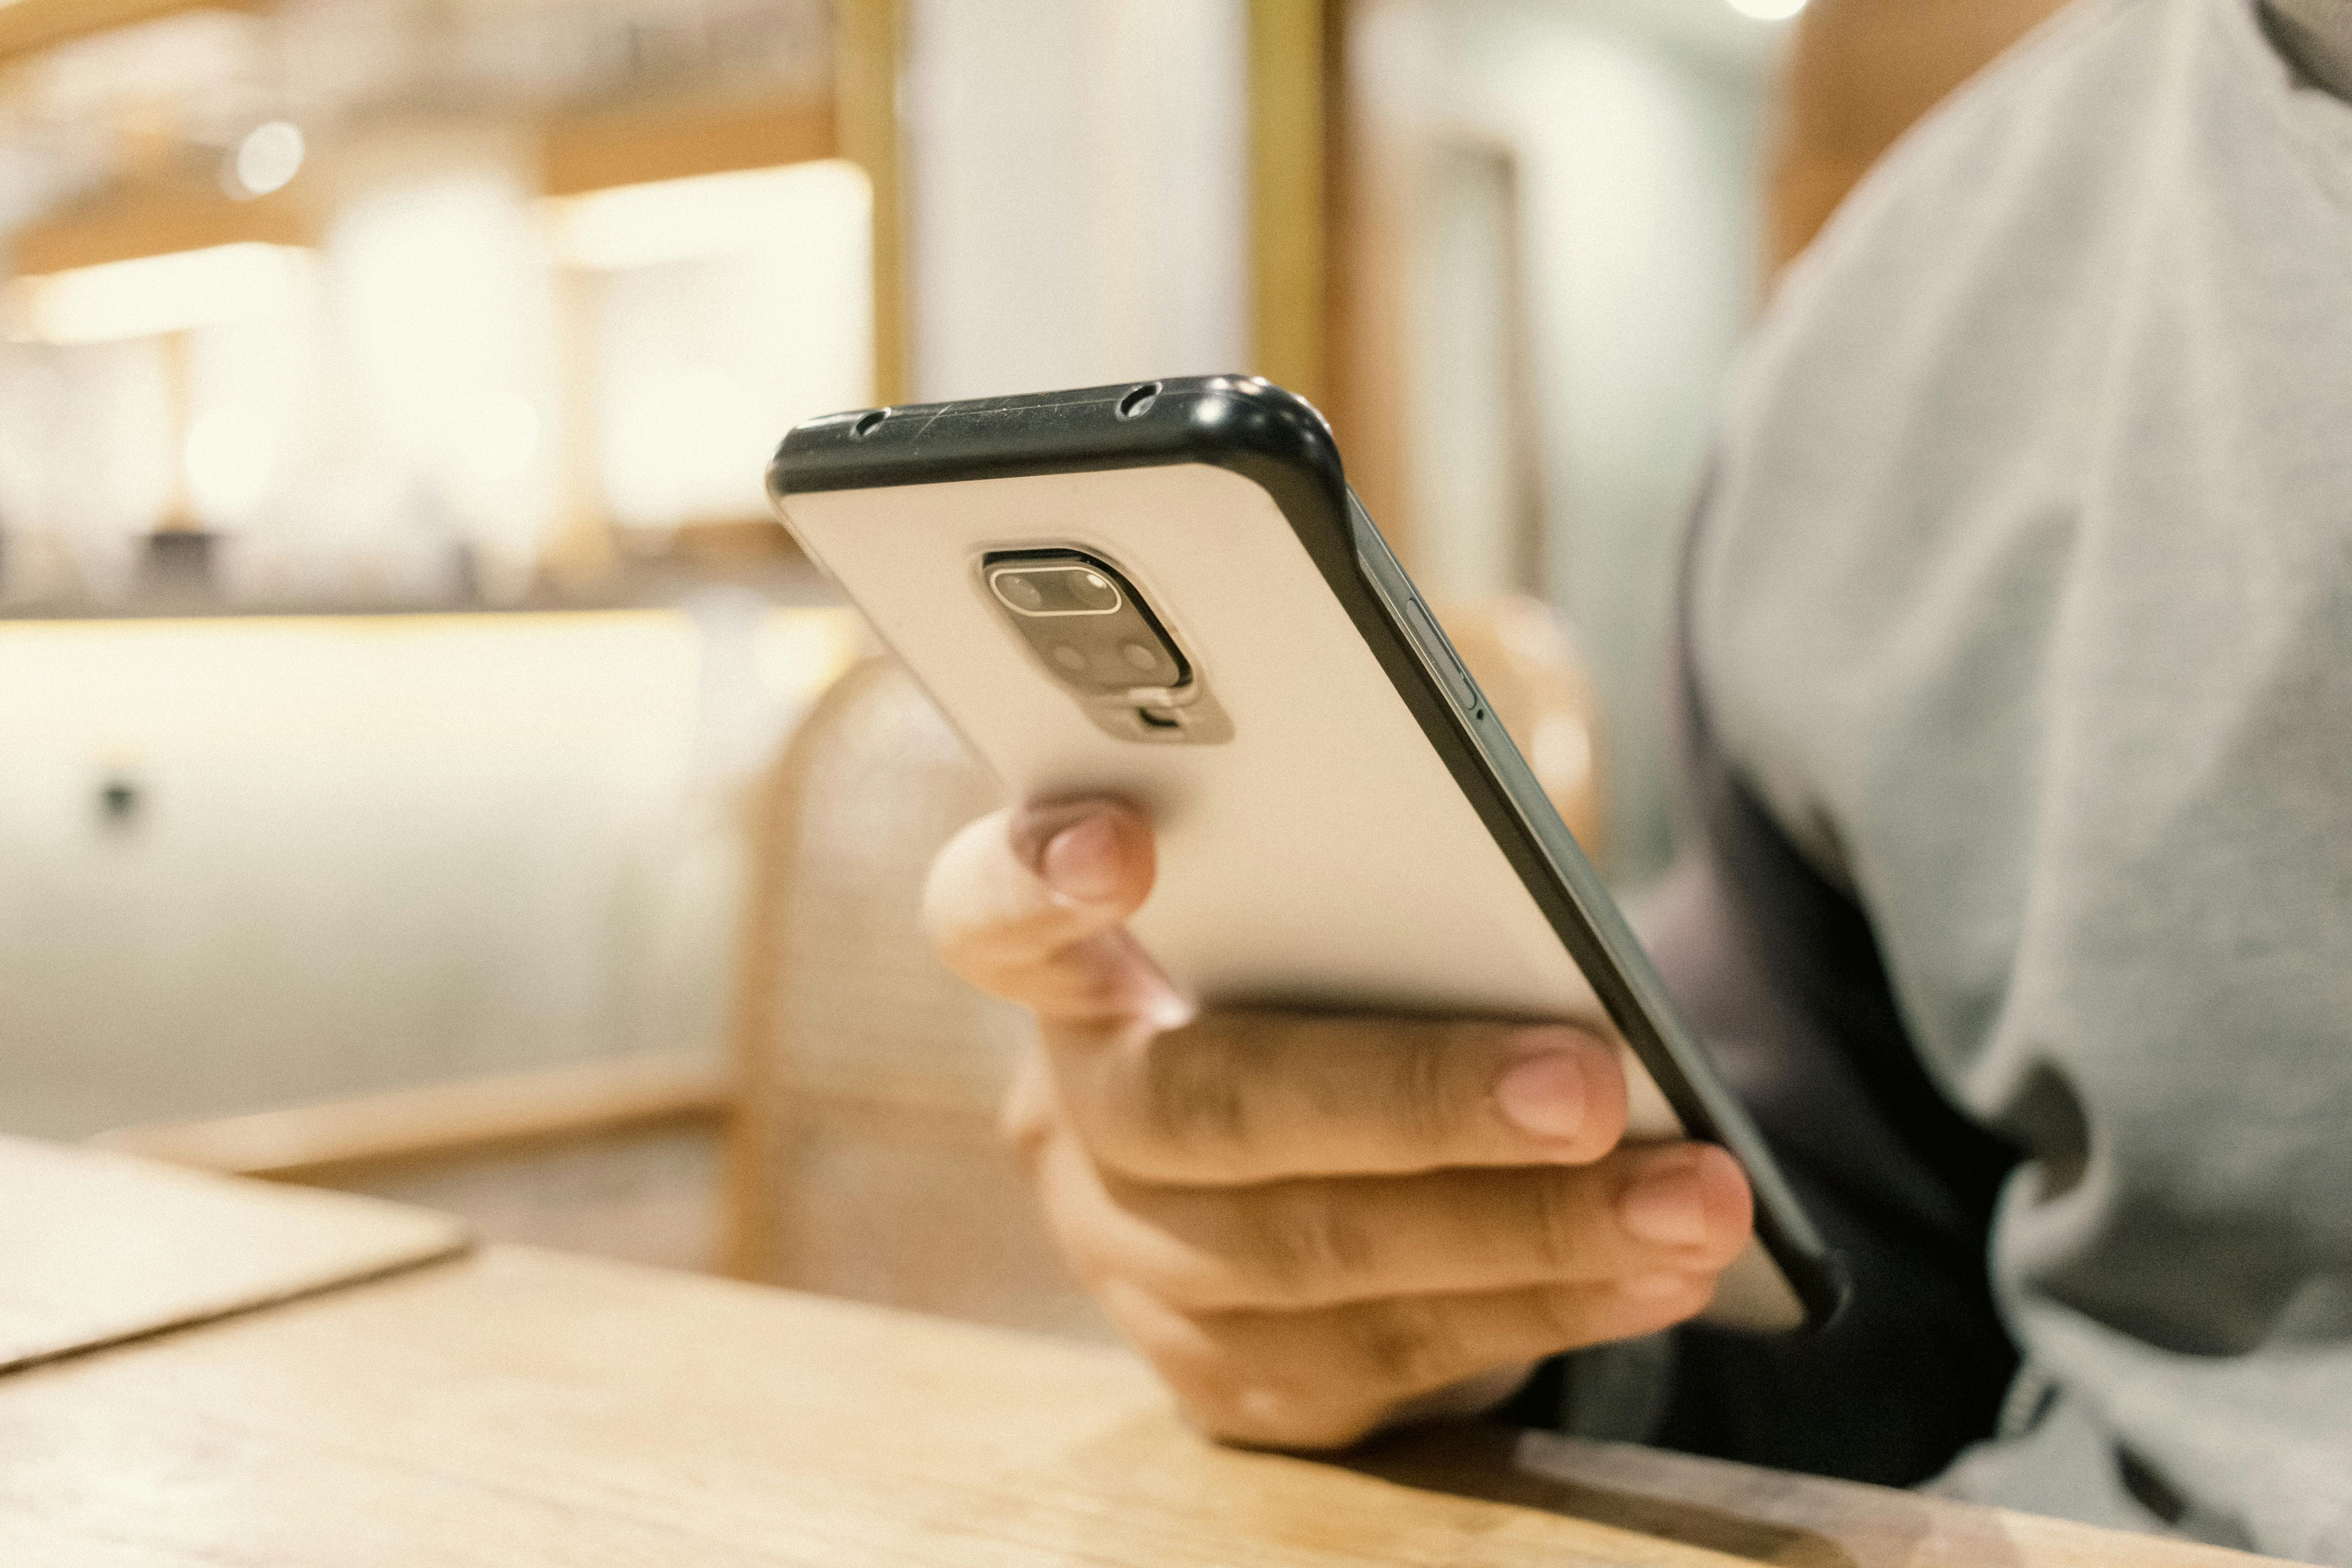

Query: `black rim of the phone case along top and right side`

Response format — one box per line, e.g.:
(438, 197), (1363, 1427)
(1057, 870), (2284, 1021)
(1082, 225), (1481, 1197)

(767, 376), (1849, 1331)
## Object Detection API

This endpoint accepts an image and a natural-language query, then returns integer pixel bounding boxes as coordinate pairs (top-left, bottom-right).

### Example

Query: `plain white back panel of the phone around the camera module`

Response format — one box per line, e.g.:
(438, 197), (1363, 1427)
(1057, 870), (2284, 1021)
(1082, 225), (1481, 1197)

(785, 463), (1804, 1326)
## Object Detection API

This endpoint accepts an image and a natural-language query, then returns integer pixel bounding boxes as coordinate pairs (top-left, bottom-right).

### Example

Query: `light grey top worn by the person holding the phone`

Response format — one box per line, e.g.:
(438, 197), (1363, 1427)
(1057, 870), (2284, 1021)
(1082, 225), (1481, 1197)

(1689, 0), (2352, 1566)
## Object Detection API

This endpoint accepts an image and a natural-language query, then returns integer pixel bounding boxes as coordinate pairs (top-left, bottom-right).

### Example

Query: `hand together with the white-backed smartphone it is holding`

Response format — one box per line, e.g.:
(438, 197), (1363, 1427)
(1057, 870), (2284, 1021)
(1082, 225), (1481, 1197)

(769, 376), (1844, 1446)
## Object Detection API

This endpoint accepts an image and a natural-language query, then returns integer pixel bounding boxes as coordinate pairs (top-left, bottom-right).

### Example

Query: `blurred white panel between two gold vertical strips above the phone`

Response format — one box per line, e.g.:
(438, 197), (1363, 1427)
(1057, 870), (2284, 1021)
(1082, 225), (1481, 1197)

(901, 0), (1247, 400)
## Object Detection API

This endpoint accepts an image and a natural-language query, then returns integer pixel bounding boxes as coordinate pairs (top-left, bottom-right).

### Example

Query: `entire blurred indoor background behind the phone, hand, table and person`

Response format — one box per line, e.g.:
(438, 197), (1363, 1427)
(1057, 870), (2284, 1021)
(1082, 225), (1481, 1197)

(0, 0), (2046, 1331)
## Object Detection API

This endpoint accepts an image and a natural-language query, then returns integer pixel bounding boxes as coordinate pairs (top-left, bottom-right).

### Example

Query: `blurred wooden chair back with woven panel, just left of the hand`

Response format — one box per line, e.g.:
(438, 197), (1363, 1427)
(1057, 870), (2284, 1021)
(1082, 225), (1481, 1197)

(729, 658), (1108, 1335)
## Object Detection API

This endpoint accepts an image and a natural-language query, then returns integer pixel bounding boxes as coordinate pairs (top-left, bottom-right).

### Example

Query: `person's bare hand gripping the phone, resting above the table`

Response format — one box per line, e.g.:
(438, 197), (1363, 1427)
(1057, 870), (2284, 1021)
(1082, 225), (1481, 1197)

(926, 802), (1750, 1448)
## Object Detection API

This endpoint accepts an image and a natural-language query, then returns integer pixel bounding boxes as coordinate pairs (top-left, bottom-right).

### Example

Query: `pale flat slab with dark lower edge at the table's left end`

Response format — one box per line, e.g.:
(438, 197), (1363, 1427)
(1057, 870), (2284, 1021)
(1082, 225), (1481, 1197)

(0, 1138), (466, 1373)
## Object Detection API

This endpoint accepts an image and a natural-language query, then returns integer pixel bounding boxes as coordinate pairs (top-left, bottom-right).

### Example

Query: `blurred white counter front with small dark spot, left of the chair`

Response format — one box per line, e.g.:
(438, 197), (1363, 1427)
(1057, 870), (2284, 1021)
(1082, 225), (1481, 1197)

(0, 606), (856, 1138)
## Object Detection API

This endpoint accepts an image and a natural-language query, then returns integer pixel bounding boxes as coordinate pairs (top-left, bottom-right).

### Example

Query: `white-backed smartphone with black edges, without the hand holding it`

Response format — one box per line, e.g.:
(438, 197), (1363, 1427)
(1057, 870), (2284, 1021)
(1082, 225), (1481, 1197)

(767, 376), (1846, 1331)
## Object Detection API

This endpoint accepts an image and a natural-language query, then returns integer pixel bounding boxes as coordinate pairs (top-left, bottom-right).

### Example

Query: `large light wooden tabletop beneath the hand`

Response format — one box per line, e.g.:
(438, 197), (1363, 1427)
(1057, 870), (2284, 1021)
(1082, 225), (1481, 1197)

(0, 1248), (2286, 1568)
